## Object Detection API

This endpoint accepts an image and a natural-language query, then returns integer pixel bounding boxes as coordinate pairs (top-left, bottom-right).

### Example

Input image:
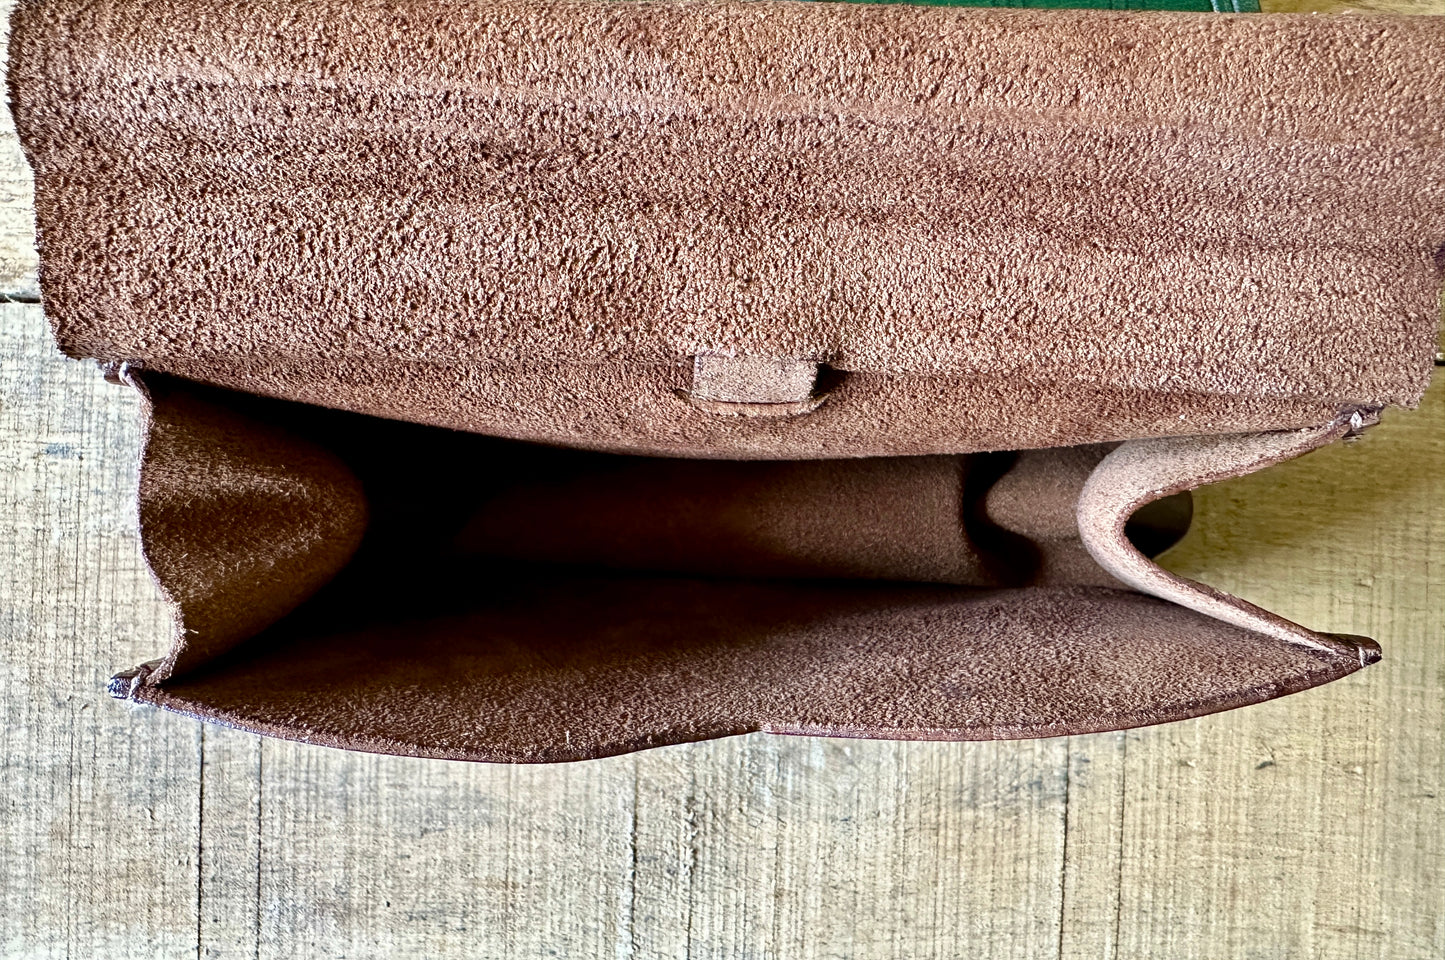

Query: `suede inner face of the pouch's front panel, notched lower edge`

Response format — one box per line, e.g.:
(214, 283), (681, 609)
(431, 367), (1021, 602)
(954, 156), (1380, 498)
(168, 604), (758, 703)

(137, 578), (1360, 762)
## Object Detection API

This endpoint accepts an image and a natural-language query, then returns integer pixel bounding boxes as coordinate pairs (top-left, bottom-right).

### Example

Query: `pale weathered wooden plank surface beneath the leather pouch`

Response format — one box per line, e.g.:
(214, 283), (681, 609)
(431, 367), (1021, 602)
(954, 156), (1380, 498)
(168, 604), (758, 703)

(0, 4), (1445, 960)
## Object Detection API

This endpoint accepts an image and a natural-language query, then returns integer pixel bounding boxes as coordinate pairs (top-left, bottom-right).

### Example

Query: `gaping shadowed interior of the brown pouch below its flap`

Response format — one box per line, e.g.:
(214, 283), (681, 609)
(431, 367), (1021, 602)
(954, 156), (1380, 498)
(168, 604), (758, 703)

(117, 376), (1373, 762)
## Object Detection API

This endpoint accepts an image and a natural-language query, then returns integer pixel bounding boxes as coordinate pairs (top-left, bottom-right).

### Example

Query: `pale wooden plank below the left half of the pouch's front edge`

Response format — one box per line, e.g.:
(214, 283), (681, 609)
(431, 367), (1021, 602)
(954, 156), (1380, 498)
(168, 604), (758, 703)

(244, 743), (644, 957)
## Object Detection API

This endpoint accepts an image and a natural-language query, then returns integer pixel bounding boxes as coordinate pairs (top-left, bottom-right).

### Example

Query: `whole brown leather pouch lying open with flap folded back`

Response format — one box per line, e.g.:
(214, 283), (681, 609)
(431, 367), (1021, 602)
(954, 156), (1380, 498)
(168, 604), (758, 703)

(10, 0), (1445, 762)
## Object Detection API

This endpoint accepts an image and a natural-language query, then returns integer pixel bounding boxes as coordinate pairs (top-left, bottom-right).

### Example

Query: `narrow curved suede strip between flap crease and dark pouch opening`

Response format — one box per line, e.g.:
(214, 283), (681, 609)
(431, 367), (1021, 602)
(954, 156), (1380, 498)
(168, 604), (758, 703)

(96, 355), (1369, 460)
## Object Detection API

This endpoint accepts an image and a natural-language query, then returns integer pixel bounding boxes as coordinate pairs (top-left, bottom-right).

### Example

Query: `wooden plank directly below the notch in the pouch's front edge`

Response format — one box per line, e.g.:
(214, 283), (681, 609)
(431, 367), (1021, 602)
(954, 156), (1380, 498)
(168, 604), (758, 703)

(633, 736), (1066, 957)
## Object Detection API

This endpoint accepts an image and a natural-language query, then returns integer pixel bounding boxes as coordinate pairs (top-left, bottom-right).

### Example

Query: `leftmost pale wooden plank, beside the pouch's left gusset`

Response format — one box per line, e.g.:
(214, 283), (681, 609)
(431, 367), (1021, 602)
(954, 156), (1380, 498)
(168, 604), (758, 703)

(0, 304), (199, 957)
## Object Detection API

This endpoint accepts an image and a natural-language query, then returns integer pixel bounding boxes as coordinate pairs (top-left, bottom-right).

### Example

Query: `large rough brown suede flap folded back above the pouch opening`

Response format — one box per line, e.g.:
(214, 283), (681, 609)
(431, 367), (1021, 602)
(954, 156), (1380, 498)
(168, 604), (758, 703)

(10, 0), (1445, 458)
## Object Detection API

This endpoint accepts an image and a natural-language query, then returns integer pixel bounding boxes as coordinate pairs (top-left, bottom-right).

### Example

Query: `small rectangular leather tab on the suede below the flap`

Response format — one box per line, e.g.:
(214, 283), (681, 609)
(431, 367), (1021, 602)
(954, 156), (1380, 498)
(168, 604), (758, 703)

(686, 353), (822, 416)
